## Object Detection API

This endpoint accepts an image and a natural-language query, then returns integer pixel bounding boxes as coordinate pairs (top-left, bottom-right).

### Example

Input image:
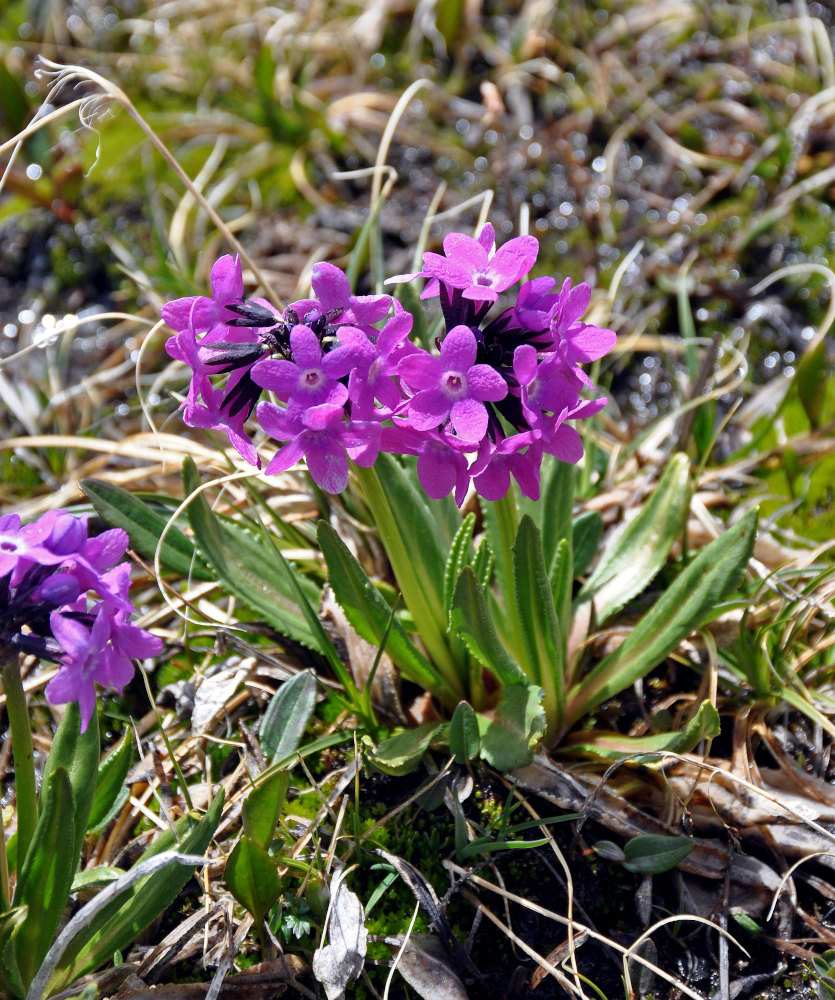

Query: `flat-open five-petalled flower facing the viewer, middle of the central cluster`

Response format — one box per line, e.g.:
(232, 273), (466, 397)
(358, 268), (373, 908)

(398, 326), (507, 441)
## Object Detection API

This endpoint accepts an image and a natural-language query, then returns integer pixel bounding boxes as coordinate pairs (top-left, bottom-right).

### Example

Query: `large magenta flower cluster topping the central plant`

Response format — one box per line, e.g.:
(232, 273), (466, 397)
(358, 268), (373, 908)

(162, 229), (615, 506)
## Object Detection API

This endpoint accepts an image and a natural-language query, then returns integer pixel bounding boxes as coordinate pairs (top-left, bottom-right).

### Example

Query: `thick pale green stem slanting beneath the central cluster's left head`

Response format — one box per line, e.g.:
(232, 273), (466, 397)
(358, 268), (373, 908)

(356, 466), (465, 704)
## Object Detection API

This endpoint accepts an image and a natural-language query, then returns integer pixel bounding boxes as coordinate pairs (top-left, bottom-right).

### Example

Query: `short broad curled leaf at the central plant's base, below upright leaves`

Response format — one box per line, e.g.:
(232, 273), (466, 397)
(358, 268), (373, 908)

(478, 684), (545, 771)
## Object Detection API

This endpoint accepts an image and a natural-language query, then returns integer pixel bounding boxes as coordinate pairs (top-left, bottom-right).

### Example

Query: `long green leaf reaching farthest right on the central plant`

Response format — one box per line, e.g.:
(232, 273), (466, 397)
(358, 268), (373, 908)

(566, 510), (757, 727)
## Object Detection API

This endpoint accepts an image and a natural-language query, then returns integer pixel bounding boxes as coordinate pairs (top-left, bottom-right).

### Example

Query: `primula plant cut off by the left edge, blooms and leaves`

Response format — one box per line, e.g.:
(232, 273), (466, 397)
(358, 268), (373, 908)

(0, 510), (222, 997)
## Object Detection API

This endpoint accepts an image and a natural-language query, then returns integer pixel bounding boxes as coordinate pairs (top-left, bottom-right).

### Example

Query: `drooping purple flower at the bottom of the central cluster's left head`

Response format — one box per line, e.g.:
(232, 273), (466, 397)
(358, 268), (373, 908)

(257, 403), (380, 493)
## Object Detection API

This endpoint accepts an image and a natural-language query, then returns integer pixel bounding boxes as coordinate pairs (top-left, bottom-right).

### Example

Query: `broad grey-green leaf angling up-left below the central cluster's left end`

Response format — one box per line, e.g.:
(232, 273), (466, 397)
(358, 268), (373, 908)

(183, 457), (324, 652)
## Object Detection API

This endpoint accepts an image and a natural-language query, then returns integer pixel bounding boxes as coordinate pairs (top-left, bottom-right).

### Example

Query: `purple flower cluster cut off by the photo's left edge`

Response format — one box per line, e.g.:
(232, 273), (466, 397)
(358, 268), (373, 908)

(0, 510), (162, 732)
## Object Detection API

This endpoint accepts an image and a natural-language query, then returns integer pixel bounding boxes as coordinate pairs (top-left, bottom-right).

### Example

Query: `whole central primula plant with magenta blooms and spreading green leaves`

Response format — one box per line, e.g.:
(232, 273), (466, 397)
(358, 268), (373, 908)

(144, 224), (754, 771)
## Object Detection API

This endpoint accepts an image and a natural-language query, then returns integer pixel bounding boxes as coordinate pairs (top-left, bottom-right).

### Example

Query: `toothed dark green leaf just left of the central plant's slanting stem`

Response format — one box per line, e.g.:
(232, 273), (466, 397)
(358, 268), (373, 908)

(318, 521), (452, 699)
